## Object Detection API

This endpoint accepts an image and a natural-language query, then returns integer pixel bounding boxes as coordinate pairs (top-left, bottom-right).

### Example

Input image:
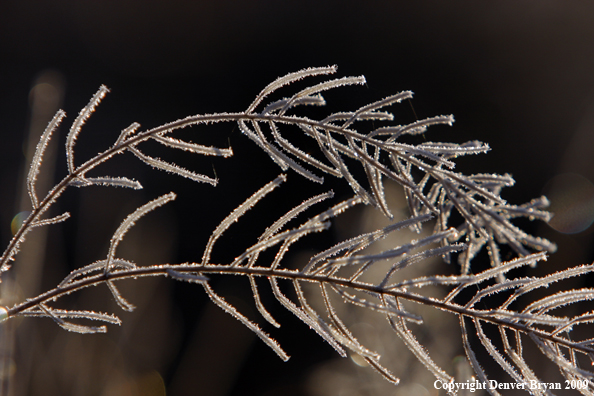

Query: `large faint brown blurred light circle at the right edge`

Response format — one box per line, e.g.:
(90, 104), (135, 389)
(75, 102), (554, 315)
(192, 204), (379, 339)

(545, 173), (594, 234)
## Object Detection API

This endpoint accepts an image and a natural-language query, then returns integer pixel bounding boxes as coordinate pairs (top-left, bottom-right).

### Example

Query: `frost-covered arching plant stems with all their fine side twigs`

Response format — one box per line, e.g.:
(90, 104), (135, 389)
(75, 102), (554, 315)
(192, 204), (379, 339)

(0, 66), (594, 395)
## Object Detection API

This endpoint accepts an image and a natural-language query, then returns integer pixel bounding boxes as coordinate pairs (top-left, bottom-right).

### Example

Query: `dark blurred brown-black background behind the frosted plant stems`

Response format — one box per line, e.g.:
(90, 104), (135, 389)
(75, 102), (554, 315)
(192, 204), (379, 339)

(0, 0), (594, 396)
